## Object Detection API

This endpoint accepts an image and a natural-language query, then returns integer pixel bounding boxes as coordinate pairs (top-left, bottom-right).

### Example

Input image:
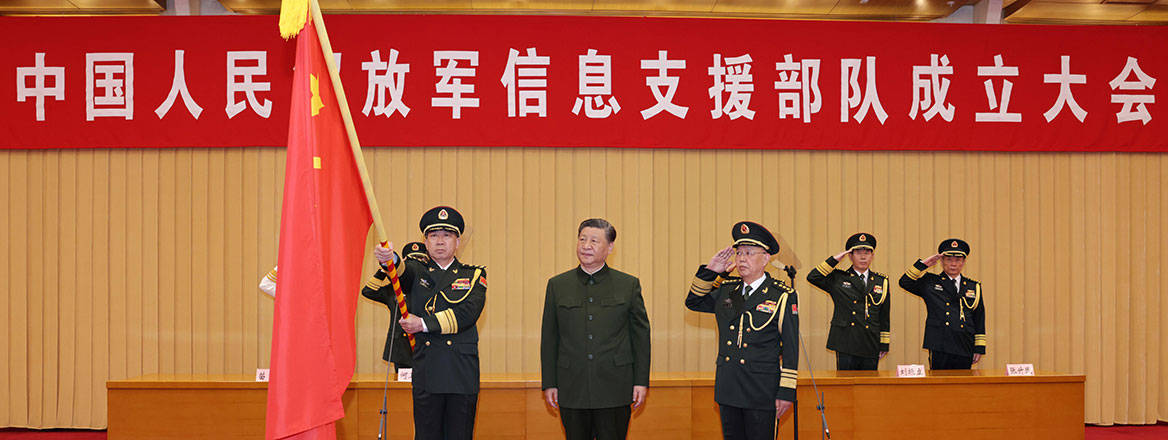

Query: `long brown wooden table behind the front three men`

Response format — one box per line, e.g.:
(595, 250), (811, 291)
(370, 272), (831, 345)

(106, 370), (1084, 440)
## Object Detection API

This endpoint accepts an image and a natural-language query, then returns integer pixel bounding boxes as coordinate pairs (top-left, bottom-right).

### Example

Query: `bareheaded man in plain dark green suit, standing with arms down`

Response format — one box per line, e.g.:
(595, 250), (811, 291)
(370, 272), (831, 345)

(540, 218), (649, 440)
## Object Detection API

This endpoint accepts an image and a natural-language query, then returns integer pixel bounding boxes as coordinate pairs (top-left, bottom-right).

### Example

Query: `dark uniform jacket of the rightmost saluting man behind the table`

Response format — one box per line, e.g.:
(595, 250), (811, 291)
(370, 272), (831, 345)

(901, 260), (986, 357)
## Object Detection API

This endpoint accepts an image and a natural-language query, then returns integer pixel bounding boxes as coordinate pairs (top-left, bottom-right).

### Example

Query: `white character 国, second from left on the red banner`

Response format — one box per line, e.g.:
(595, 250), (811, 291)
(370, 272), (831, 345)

(85, 53), (134, 120)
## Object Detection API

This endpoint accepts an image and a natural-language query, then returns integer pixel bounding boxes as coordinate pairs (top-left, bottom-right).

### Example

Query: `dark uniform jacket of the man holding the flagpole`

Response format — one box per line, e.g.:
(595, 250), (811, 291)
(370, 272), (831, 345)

(366, 258), (487, 394)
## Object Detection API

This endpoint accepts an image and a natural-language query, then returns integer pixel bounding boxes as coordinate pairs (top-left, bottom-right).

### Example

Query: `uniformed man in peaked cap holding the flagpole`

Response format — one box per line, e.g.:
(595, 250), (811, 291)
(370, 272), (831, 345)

(366, 207), (487, 440)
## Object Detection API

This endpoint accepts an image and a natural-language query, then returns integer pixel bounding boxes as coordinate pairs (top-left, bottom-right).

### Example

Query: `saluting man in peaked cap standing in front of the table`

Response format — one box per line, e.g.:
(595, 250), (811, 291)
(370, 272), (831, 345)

(686, 222), (799, 440)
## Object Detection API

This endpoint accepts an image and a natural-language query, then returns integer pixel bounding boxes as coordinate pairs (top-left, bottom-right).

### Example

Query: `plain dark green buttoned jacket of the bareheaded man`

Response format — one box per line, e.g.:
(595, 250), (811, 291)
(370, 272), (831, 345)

(540, 266), (649, 408)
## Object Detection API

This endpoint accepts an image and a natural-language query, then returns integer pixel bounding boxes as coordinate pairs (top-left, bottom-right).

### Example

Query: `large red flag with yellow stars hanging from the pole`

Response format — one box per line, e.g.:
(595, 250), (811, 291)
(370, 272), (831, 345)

(265, 13), (373, 440)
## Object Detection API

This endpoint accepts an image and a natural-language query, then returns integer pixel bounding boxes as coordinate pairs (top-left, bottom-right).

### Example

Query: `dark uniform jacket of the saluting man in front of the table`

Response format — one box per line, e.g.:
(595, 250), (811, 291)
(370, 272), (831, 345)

(686, 265), (799, 410)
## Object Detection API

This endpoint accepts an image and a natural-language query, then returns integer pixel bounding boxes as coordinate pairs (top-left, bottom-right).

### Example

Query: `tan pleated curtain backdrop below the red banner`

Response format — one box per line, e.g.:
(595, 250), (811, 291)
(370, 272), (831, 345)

(0, 148), (1168, 427)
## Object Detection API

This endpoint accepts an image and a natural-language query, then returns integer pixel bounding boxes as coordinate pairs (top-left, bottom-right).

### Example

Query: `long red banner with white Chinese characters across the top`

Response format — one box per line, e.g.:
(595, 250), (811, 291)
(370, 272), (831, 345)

(0, 15), (1168, 152)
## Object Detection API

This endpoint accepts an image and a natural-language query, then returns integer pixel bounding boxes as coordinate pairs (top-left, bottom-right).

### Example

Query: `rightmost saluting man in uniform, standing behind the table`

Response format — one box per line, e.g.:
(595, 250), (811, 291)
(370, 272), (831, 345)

(901, 238), (986, 370)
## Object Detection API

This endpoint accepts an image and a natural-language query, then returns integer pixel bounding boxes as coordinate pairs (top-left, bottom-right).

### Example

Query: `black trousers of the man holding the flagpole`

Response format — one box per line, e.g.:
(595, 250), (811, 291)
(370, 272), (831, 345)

(413, 389), (479, 440)
